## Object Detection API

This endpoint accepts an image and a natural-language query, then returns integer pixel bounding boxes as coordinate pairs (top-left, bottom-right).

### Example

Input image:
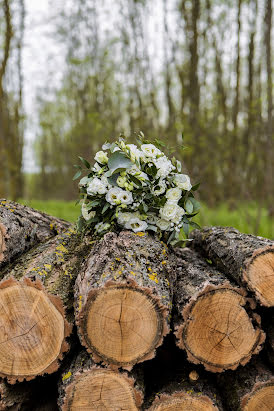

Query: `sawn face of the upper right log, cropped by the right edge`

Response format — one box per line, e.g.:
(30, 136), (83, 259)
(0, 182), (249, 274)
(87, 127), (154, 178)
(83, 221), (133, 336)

(244, 246), (274, 307)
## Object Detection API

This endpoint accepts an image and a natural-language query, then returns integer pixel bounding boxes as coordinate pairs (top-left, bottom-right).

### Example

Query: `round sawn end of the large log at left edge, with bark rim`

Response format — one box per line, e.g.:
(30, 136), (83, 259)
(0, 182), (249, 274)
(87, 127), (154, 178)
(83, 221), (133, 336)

(0, 278), (71, 383)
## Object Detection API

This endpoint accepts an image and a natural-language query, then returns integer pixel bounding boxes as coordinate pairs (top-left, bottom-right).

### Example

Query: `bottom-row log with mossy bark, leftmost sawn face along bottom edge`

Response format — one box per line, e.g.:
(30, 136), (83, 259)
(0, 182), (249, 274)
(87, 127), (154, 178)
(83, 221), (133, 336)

(58, 351), (143, 411)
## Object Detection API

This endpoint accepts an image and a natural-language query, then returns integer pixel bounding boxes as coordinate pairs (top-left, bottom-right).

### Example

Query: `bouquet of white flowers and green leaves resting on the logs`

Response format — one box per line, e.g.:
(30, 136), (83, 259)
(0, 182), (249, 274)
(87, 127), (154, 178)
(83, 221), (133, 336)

(74, 133), (200, 244)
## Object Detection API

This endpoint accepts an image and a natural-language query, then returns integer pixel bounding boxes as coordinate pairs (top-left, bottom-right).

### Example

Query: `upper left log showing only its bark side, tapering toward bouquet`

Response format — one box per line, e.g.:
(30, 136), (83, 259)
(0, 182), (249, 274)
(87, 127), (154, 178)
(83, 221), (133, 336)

(0, 200), (71, 267)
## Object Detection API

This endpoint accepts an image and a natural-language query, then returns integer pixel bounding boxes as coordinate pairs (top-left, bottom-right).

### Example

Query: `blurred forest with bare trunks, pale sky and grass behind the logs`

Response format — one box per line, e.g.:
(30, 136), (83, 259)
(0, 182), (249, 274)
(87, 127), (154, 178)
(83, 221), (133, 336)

(0, 0), (274, 238)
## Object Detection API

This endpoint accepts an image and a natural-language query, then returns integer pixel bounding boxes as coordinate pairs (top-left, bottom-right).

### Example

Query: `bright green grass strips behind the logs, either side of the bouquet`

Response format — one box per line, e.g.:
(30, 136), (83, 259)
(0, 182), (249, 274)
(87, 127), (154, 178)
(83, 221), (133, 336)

(20, 200), (274, 239)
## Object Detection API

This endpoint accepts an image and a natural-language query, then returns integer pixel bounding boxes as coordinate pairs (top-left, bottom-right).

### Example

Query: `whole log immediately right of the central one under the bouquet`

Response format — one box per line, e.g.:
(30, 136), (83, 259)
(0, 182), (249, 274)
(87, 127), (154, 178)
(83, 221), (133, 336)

(174, 248), (265, 372)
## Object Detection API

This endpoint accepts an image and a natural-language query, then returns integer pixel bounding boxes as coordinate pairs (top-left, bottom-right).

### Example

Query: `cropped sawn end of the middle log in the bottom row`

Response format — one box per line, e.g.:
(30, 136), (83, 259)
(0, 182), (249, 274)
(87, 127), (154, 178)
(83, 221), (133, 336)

(149, 392), (218, 411)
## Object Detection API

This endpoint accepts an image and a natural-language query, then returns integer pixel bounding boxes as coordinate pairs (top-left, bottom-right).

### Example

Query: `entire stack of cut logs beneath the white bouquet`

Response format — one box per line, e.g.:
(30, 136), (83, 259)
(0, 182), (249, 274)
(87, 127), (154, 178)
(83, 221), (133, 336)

(0, 204), (274, 411)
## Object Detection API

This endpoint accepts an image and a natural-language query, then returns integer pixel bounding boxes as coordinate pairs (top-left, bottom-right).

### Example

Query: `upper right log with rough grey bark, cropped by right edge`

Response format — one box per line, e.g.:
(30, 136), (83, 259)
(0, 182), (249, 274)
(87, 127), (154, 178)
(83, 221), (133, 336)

(191, 227), (274, 307)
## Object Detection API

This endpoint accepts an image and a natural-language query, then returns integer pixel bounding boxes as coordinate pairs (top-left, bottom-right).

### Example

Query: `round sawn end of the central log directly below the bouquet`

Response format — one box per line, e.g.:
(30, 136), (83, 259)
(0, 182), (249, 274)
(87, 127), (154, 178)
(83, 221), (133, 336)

(77, 282), (168, 370)
